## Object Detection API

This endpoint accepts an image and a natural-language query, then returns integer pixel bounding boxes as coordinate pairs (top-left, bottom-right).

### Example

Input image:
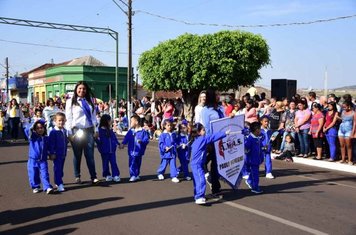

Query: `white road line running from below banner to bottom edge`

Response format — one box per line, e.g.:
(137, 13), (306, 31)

(221, 200), (327, 235)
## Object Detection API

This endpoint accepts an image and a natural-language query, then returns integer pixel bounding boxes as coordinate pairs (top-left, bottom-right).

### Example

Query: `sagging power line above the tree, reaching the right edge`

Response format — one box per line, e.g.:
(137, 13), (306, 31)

(135, 10), (356, 28)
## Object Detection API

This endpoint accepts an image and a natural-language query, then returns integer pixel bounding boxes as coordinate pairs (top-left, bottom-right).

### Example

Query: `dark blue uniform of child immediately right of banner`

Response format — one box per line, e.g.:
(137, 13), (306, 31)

(245, 133), (264, 190)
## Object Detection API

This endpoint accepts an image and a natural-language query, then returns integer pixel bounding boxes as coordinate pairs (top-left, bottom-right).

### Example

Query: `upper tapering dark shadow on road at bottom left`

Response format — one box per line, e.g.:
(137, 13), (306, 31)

(0, 197), (123, 227)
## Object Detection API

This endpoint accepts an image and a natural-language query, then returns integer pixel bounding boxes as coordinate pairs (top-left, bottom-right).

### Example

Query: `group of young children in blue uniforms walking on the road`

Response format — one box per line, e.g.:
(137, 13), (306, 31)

(28, 112), (278, 204)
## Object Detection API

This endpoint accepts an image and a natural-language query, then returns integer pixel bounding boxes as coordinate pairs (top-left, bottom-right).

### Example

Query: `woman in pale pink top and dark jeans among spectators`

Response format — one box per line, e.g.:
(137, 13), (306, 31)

(294, 100), (311, 158)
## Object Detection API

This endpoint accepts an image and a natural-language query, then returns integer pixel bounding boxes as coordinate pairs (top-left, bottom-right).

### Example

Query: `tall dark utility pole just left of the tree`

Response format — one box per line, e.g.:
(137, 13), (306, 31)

(127, 0), (132, 117)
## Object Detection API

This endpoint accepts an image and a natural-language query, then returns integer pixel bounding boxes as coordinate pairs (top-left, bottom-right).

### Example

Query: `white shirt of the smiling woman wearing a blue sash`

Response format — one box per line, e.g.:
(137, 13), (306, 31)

(65, 97), (97, 135)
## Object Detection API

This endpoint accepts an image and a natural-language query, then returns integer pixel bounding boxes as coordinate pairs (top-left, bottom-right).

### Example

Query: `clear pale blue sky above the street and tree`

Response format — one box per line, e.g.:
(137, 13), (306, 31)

(0, 0), (356, 89)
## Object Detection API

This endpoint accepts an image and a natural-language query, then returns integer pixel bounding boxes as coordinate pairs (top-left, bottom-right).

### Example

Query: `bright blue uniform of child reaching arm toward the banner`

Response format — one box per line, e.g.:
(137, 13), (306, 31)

(190, 132), (226, 200)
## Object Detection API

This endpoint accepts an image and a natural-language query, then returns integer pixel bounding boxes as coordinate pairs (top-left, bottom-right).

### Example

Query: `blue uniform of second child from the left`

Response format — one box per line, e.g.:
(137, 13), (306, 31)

(48, 126), (68, 185)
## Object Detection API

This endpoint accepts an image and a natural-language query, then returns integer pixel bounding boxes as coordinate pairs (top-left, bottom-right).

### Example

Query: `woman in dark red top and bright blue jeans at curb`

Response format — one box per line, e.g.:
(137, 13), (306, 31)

(323, 102), (339, 162)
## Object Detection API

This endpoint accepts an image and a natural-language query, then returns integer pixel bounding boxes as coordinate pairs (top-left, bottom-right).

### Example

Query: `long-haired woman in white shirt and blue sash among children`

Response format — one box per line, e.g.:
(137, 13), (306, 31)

(66, 81), (99, 184)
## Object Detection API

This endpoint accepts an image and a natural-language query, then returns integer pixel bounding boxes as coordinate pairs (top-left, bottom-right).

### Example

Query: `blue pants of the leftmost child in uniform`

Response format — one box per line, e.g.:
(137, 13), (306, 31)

(27, 158), (52, 190)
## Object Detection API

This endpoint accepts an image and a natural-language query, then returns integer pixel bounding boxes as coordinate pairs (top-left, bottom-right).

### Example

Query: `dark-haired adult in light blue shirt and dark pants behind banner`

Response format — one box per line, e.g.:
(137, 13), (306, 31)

(201, 88), (224, 195)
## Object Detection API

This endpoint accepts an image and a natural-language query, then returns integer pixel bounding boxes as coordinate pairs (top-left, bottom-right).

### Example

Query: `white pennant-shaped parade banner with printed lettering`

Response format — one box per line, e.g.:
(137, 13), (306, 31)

(210, 115), (245, 188)
